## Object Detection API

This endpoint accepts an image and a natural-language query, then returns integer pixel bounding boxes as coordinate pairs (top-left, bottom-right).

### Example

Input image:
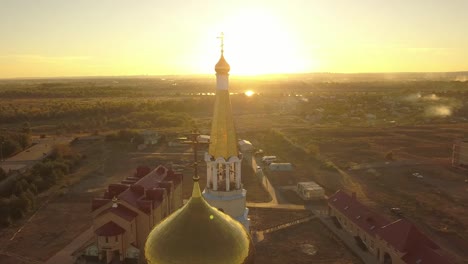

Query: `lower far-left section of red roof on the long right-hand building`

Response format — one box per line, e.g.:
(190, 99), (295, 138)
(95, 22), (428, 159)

(328, 190), (390, 236)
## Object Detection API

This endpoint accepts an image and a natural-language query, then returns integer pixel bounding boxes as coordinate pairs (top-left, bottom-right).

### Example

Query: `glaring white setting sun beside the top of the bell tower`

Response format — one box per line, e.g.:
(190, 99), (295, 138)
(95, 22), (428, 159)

(215, 10), (316, 75)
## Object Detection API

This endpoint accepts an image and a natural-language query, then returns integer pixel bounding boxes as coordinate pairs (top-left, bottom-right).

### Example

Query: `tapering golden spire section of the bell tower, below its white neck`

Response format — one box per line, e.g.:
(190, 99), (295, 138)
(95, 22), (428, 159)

(208, 89), (239, 160)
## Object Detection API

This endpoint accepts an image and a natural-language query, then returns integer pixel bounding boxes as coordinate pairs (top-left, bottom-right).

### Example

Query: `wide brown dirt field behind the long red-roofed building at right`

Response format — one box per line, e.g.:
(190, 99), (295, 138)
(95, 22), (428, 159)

(255, 124), (468, 263)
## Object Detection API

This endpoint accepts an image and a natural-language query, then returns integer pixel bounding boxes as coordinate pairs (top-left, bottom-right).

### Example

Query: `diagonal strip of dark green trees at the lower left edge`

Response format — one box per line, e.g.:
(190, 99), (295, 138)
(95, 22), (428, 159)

(0, 145), (80, 226)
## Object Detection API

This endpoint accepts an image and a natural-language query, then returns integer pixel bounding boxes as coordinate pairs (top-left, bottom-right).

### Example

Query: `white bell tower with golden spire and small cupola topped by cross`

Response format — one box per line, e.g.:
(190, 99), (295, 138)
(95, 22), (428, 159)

(203, 33), (250, 230)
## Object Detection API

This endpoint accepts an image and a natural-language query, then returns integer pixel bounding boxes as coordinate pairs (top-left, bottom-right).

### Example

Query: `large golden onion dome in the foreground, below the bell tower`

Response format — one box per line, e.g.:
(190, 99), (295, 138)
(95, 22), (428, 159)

(145, 178), (255, 264)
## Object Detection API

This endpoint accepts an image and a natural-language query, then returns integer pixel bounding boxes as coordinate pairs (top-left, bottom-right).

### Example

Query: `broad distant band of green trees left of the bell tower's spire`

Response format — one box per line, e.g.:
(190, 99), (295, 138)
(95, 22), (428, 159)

(0, 100), (203, 130)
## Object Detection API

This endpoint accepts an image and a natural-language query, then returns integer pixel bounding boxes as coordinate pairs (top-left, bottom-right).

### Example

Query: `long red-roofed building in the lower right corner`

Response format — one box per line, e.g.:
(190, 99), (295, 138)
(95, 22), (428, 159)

(328, 190), (453, 264)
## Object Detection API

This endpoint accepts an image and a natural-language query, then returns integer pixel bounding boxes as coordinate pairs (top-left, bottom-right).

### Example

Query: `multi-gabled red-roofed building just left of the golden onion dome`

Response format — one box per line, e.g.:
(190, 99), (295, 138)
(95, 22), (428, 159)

(85, 166), (183, 263)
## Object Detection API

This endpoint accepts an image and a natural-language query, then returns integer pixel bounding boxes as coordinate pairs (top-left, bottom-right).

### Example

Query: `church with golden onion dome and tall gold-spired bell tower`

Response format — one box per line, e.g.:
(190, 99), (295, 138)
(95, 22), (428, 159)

(145, 37), (255, 264)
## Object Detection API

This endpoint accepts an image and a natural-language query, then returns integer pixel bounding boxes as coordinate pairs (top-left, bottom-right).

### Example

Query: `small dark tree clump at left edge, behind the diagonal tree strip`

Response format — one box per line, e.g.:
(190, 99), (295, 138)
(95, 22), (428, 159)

(0, 129), (31, 159)
